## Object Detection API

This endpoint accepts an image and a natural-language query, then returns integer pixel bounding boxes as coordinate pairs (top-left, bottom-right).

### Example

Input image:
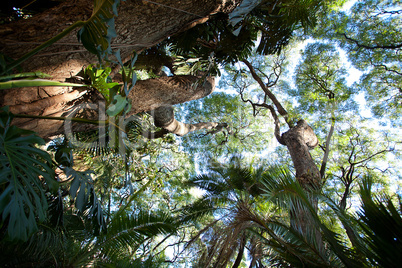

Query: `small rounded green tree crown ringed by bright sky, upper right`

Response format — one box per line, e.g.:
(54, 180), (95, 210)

(292, 43), (355, 117)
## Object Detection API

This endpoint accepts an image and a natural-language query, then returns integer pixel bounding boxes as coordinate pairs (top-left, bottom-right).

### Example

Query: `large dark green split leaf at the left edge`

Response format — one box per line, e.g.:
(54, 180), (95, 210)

(0, 109), (58, 240)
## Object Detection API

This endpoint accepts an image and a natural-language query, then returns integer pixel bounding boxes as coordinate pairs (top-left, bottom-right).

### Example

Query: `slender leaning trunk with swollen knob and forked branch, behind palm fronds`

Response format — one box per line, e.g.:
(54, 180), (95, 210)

(243, 60), (324, 250)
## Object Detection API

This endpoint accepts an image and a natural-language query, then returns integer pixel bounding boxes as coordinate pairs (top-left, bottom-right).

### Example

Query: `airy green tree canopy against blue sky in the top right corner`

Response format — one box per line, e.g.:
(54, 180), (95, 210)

(313, 0), (402, 124)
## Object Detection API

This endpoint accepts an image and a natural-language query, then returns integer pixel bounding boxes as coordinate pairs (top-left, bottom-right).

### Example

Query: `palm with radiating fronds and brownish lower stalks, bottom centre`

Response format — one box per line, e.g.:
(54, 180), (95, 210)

(182, 158), (314, 267)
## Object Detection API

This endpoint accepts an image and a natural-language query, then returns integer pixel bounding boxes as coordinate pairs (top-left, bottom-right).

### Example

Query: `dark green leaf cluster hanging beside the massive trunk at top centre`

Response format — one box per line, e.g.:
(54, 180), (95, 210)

(166, 0), (322, 75)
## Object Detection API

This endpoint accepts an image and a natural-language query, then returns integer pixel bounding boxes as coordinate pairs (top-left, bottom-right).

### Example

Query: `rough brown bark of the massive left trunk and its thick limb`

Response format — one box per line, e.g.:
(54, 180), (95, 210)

(0, 0), (241, 138)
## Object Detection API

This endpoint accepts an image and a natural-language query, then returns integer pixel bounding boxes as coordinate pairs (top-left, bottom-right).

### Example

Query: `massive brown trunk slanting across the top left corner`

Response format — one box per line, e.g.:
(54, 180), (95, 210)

(0, 0), (241, 80)
